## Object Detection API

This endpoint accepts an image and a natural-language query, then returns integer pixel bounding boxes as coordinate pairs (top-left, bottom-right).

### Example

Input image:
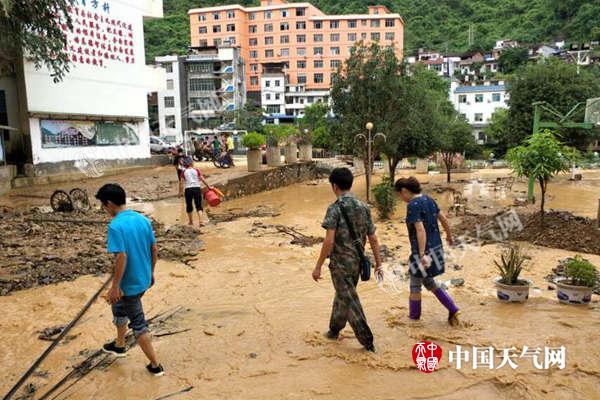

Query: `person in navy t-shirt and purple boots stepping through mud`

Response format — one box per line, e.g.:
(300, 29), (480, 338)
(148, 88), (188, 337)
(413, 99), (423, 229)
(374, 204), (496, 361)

(394, 177), (459, 326)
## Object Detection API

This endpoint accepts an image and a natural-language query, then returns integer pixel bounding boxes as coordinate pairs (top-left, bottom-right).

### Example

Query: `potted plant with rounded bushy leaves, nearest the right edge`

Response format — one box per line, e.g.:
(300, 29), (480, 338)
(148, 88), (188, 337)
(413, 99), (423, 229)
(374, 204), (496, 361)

(556, 255), (598, 304)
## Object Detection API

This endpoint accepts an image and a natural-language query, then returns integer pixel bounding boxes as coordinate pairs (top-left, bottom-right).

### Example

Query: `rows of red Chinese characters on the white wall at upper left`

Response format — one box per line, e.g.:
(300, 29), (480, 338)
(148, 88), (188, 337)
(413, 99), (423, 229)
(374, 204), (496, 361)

(61, 0), (136, 68)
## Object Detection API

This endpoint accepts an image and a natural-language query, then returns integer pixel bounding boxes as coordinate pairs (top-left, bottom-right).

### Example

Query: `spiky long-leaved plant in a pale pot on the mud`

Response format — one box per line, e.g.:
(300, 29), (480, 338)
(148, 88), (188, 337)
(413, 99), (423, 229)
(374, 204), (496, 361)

(494, 246), (531, 303)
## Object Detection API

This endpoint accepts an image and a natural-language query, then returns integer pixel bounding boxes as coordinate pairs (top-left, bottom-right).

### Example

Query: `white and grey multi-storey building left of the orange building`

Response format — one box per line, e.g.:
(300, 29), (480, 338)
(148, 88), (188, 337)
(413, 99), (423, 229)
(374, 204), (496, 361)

(155, 46), (246, 142)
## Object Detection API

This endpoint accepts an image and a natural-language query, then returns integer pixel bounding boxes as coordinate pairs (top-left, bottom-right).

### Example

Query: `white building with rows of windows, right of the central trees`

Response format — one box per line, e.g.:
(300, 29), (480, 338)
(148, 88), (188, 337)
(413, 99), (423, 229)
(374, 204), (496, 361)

(450, 81), (508, 144)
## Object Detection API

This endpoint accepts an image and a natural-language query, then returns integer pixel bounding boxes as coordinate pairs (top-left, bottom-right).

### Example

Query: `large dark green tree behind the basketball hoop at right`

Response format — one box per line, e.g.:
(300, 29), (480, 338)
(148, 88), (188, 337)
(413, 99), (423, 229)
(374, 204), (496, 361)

(503, 59), (600, 148)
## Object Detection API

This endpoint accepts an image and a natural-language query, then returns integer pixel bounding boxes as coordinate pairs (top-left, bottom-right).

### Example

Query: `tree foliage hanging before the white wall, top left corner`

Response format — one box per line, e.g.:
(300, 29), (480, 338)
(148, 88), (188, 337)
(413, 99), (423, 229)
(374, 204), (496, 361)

(0, 0), (73, 82)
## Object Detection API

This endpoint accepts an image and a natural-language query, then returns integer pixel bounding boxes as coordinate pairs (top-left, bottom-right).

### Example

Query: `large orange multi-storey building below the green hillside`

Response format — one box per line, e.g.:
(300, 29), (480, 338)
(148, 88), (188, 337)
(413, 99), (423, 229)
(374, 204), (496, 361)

(188, 0), (404, 117)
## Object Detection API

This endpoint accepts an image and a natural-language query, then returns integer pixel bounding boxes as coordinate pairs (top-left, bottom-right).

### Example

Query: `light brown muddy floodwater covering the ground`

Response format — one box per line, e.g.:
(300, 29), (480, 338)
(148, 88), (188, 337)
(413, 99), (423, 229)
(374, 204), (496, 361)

(0, 170), (600, 400)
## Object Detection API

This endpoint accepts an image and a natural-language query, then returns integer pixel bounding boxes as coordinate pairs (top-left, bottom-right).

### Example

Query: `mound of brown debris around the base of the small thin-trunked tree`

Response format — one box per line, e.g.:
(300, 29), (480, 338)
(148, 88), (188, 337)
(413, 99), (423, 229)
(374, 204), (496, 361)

(456, 210), (600, 254)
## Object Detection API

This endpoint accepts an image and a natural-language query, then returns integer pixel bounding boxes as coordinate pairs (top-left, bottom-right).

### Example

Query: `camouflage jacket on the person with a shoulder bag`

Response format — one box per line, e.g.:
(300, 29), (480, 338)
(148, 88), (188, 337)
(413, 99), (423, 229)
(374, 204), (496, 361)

(321, 193), (375, 272)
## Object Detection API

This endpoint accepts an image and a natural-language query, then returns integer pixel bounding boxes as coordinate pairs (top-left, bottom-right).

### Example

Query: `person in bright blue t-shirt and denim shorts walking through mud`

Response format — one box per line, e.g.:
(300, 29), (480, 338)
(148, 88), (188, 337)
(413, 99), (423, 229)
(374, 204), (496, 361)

(96, 183), (164, 376)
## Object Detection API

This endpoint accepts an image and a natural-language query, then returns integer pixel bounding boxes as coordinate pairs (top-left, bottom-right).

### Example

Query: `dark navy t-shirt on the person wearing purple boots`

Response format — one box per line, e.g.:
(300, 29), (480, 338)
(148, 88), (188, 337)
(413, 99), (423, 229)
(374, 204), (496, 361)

(406, 195), (444, 272)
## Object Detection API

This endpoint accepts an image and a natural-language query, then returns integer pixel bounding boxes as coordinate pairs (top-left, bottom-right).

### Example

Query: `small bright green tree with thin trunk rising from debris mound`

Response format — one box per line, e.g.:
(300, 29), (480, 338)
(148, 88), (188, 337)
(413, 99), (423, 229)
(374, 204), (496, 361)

(506, 130), (577, 226)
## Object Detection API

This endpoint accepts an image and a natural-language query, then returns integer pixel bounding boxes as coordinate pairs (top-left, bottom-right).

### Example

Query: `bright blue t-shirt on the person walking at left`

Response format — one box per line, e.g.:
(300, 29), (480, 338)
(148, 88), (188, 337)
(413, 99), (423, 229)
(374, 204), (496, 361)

(107, 210), (156, 296)
